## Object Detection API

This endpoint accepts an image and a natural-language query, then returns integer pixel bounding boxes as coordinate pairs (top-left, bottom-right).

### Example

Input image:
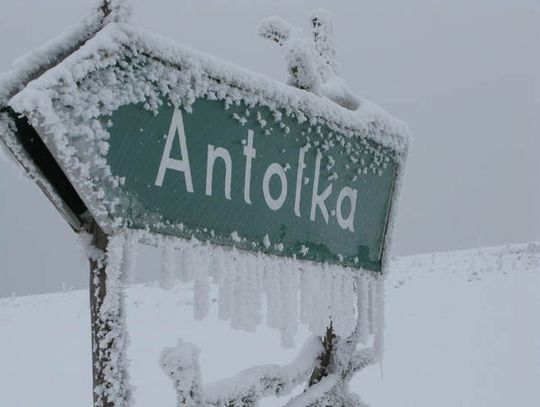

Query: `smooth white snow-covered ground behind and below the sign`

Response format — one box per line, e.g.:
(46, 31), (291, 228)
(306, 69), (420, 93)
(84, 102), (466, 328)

(0, 243), (540, 407)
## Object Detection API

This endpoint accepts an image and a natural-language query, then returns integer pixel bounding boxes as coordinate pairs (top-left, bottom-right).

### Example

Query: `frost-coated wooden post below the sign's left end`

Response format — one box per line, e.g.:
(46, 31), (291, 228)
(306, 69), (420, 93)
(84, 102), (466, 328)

(87, 220), (128, 407)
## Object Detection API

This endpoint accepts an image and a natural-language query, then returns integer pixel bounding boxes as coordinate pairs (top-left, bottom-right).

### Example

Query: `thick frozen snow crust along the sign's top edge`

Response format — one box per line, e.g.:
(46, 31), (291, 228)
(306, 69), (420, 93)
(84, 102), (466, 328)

(10, 24), (409, 160)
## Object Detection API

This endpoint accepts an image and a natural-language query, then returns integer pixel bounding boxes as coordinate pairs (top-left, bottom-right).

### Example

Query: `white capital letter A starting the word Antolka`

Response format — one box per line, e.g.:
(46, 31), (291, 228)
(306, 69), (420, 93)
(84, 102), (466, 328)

(156, 109), (193, 193)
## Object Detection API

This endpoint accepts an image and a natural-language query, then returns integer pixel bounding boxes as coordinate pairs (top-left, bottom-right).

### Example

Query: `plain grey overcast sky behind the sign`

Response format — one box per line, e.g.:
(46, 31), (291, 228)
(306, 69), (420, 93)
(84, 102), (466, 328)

(0, 0), (540, 296)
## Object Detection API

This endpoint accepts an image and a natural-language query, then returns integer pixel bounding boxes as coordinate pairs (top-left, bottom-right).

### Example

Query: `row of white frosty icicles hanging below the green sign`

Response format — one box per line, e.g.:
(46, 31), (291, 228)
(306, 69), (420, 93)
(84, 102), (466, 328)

(123, 235), (384, 347)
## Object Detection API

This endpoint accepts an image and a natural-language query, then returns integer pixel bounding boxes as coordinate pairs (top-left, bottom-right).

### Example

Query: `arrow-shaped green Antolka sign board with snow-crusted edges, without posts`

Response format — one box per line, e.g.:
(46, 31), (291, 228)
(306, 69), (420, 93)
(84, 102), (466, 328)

(2, 24), (406, 271)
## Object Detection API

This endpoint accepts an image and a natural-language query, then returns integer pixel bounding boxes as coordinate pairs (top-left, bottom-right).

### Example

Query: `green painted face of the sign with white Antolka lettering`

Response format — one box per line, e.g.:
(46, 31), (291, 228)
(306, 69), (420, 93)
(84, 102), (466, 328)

(103, 99), (396, 271)
